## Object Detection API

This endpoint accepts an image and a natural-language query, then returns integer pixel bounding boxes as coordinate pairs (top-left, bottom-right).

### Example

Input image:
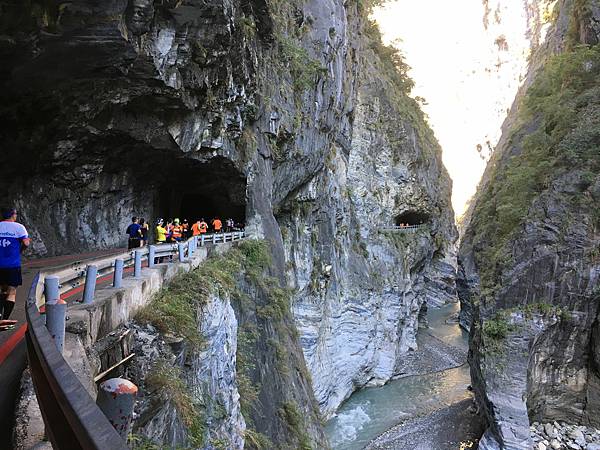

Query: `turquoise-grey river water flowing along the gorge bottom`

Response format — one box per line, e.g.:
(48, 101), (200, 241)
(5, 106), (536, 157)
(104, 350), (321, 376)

(326, 304), (471, 450)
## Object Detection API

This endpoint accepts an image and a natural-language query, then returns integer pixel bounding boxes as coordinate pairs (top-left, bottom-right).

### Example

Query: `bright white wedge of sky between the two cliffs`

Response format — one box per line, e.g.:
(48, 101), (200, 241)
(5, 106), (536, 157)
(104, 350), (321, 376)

(373, 0), (530, 217)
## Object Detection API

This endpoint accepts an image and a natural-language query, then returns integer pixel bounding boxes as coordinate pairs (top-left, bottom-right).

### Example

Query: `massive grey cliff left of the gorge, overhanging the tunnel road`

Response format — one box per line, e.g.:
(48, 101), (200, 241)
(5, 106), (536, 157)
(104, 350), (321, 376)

(0, 0), (456, 448)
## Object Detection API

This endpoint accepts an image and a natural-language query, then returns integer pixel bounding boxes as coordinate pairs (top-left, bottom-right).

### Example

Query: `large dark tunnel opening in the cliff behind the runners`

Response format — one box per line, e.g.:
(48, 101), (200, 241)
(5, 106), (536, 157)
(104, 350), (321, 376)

(0, 129), (246, 256)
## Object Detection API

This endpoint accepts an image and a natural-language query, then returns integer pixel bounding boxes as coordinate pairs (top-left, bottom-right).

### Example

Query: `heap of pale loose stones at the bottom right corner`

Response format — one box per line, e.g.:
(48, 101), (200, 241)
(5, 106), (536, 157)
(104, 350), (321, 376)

(530, 422), (600, 450)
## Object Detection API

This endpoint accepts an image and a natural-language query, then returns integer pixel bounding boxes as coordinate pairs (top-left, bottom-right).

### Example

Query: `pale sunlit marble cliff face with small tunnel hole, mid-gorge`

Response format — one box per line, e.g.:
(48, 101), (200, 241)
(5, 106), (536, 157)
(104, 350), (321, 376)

(278, 33), (456, 416)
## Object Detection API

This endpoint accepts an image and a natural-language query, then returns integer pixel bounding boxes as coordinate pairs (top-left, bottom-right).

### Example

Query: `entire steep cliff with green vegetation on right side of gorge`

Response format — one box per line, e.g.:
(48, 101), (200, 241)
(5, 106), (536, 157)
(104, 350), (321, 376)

(458, 0), (600, 449)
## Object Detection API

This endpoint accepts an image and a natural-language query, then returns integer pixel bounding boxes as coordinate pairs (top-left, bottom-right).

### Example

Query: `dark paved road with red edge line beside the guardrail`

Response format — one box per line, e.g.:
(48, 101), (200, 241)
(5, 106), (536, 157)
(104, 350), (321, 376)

(0, 249), (125, 450)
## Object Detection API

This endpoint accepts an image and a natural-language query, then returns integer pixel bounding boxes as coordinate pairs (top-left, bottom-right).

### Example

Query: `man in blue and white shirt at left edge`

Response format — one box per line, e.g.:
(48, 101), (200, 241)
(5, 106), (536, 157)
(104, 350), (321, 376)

(0, 208), (30, 320)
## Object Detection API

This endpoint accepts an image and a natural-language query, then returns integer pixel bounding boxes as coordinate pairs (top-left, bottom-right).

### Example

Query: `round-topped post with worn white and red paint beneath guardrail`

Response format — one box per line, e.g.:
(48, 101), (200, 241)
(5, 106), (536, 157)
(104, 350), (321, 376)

(96, 378), (138, 439)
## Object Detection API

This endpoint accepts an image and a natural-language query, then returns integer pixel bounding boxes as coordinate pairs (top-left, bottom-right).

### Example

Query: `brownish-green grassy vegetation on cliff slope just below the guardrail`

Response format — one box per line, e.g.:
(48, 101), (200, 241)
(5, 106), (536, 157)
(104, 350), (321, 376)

(138, 240), (319, 449)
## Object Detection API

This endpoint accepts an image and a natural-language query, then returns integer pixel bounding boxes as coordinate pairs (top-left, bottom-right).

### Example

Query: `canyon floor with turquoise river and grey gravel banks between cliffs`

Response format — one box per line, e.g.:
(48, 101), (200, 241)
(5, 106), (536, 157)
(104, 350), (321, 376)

(326, 303), (483, 450)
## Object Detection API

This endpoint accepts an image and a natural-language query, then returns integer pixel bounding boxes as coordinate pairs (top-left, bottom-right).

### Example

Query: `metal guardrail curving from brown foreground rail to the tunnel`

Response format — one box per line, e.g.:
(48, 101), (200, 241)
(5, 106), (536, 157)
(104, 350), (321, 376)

(26, 231), (245, 450)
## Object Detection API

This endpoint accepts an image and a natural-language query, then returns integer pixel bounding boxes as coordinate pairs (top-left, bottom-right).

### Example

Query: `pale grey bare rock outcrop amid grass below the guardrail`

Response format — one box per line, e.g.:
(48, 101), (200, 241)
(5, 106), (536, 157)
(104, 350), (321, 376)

(128, 296), (246, 448)
